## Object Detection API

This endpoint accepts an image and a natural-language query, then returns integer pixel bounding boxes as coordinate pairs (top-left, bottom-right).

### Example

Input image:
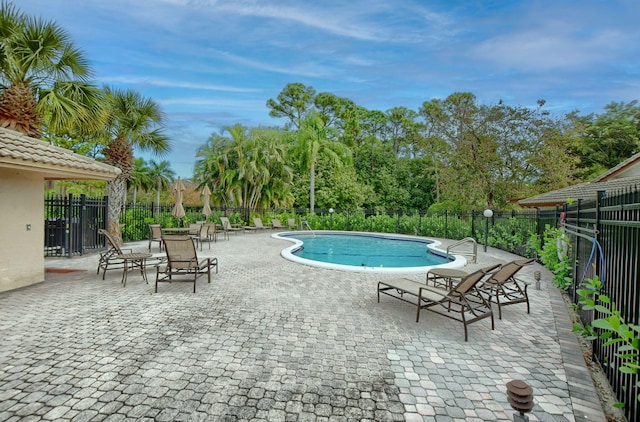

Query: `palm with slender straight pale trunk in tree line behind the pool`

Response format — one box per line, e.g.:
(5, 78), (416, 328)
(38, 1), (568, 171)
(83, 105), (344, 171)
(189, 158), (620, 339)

(295, 113), (351, 212)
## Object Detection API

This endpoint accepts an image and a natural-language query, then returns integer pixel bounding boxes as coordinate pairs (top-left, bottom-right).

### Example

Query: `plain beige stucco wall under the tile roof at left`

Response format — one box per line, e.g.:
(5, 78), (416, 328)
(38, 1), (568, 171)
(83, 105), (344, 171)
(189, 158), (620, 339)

(0, 168), (44, 291)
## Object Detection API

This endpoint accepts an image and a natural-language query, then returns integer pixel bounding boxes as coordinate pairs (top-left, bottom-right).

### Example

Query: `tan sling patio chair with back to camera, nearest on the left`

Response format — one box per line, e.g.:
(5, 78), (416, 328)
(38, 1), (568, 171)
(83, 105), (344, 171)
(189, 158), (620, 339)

(156, 236), (218, 293)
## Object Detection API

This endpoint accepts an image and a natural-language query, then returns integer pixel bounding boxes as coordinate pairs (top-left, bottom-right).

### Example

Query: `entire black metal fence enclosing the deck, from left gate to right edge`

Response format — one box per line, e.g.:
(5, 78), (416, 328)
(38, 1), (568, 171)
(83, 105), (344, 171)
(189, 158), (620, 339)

(45, 189), (640, 420)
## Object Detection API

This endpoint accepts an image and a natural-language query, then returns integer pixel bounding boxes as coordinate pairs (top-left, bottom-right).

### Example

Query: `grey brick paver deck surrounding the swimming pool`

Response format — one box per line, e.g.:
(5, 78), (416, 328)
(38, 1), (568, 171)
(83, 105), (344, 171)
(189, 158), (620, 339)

(0, 233), (605, 421)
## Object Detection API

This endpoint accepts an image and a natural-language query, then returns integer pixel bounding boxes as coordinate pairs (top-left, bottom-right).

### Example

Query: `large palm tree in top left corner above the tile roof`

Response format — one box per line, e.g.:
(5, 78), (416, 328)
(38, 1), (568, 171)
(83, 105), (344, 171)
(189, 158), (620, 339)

(0, 1), (102, 138)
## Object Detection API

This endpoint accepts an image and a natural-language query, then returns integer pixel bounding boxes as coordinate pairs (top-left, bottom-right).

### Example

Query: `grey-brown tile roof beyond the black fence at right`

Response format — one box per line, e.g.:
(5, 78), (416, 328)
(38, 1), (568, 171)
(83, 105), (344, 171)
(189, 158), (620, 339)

(518, 176), (640, 207)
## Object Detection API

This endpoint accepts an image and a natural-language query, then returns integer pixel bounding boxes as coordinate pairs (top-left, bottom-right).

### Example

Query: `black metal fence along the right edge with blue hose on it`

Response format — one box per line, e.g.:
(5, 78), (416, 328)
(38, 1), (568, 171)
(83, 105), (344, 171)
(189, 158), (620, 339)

(561, 188), (640, 421)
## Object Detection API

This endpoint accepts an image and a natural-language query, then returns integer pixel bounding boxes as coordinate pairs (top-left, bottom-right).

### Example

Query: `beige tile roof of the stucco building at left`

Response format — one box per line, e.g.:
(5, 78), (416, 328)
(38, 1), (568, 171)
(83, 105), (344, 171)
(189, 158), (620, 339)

(0, 128), (120, 180)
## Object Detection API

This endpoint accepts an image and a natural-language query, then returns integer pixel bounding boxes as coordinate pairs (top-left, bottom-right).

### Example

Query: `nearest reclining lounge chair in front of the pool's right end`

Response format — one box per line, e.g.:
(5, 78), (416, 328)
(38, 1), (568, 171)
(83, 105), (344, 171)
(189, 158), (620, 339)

(378, 264), (500, 341)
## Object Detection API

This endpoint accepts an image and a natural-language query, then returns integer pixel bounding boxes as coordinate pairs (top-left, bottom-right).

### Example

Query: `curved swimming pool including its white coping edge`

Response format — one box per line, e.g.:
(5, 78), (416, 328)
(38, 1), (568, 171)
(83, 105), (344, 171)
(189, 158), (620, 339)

(272, 231), (466, 274)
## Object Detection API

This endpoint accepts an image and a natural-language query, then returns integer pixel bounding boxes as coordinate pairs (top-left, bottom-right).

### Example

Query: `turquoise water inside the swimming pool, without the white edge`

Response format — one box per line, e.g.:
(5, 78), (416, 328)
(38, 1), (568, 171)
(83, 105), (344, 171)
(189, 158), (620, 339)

(282, 232), (452, 268)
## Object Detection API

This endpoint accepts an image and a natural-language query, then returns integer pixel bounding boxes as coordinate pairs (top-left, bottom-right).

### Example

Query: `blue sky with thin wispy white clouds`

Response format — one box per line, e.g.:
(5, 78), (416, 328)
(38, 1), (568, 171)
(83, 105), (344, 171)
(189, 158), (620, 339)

(14, 0), (640, 178)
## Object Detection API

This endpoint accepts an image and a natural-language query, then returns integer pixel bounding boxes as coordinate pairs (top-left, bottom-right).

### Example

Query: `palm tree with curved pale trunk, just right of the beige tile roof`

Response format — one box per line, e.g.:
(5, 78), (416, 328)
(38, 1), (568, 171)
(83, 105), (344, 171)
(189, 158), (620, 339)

(102, 87), (170, 237)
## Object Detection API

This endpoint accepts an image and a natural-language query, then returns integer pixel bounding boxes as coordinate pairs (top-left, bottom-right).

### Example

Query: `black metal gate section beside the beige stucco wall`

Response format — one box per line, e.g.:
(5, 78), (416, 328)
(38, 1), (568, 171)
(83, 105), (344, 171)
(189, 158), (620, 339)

(44, 194), (108, 257)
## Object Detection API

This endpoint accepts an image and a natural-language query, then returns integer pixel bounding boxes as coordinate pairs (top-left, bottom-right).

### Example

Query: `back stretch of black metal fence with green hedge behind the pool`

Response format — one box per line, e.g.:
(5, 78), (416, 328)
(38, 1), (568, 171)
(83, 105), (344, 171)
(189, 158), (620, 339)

(120, 203), (559, 257)
